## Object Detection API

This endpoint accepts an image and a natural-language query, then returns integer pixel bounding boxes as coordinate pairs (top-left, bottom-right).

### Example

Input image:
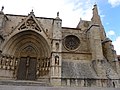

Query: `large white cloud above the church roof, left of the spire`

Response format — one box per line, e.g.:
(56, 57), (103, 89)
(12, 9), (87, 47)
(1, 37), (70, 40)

(0, 0), (95, 27)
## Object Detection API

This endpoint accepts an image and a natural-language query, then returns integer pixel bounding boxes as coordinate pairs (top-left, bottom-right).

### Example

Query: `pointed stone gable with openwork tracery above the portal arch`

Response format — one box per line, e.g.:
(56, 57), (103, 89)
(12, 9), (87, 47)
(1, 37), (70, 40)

(8, 11), (49, 38)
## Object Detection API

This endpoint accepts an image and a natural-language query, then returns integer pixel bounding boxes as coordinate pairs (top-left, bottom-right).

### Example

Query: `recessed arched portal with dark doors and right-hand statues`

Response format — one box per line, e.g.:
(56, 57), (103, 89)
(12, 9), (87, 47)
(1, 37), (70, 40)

(2, 30), (50, 80)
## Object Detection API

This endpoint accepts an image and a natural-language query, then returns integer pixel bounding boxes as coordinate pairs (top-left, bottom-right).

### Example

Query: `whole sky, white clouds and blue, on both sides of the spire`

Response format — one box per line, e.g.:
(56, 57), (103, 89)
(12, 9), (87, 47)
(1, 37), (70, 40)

(0, 0), (120, 55)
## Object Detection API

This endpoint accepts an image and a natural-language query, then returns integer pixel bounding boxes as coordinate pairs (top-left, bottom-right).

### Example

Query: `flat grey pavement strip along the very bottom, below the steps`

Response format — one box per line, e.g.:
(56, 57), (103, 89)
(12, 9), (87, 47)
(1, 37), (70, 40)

(0, 85), (120, 90)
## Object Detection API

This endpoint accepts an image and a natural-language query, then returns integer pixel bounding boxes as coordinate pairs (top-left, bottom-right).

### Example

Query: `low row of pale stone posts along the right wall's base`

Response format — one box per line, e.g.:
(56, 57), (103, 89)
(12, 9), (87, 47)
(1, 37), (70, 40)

(61, 78), (120, 88)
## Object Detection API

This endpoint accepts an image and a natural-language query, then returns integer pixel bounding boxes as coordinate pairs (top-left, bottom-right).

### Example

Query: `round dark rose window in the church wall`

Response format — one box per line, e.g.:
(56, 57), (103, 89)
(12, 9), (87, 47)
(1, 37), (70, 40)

(64, 35), (80, 50)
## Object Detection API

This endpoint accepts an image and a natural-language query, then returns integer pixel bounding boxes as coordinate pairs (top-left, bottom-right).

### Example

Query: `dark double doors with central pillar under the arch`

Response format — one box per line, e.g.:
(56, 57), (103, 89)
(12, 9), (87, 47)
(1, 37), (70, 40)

(17, 56), (37, 80)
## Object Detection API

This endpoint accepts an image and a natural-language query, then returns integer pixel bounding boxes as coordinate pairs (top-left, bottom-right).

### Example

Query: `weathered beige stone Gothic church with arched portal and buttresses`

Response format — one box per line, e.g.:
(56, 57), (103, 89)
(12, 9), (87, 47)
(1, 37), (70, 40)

(0, 5), (120, 87)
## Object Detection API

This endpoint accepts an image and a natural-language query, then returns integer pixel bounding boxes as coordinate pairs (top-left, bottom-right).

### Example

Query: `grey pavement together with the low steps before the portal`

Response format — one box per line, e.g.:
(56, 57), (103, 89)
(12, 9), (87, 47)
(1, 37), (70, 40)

(0, 80), (120, 90)
